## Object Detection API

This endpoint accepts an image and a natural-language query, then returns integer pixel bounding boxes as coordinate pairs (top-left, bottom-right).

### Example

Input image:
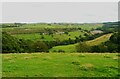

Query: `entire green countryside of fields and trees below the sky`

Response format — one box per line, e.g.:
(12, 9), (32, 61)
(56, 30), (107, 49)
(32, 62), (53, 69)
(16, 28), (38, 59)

(0, 22), (120, 77)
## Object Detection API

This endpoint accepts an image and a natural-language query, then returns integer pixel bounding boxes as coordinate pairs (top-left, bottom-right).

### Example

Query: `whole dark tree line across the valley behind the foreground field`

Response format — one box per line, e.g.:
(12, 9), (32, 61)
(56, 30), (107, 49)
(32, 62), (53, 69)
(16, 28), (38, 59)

(2, 32), (120, 53)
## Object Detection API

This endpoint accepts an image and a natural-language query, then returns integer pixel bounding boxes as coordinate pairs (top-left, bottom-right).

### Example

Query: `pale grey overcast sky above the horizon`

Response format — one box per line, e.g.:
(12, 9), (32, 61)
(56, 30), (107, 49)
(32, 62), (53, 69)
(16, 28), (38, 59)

(2, 2), (118, 23)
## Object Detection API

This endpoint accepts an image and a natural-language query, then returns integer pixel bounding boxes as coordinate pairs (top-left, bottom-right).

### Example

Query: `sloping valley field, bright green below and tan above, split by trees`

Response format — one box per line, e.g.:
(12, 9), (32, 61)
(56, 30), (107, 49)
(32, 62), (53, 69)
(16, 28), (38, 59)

(50, 34), (112, 52)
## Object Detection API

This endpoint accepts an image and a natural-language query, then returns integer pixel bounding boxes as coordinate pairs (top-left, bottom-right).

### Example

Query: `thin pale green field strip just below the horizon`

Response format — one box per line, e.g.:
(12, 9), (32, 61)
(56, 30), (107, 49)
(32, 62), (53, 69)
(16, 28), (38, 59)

(3, 23), (103, 30)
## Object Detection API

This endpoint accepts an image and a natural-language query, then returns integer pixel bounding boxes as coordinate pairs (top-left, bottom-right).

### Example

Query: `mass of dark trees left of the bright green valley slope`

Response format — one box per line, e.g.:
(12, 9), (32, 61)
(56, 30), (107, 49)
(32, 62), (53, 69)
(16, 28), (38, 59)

(2, 32), (48, 53)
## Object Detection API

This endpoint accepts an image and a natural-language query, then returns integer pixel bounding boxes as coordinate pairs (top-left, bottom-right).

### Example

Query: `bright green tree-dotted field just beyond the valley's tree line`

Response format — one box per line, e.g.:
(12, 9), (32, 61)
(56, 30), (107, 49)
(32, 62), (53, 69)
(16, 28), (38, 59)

(12, 31), (85, 41)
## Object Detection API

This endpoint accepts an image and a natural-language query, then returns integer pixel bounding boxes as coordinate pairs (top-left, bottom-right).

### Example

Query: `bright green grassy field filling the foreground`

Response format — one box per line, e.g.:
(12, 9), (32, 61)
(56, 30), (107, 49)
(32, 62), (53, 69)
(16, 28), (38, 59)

(2, 53), (120, 77)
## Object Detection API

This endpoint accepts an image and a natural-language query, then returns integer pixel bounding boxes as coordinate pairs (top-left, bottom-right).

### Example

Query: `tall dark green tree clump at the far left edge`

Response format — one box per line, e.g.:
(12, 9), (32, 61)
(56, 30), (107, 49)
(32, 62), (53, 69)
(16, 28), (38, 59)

(2, 32), (21, 53)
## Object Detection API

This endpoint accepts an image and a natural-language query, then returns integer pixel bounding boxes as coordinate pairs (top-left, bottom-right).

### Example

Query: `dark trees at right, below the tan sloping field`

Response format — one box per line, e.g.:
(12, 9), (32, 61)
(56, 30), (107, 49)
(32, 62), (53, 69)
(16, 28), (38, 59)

(76, 33), (120, 53)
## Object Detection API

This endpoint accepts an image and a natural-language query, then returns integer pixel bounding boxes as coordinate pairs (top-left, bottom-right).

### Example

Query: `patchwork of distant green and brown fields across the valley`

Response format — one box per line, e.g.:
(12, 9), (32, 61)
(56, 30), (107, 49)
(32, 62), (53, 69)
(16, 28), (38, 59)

(2, 23), (103, 41)
